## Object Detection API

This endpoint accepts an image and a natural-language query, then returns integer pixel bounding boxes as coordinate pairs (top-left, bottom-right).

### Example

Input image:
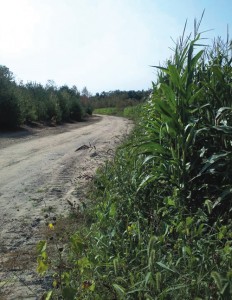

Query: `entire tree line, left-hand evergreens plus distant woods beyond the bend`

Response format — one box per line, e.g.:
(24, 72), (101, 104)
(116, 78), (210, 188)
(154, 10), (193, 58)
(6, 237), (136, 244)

(0, 65), (148, 129)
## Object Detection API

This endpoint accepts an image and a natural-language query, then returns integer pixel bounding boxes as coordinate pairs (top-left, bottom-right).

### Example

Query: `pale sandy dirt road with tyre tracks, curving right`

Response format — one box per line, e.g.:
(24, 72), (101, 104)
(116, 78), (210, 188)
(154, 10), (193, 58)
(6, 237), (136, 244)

(0, 116), (132, 299)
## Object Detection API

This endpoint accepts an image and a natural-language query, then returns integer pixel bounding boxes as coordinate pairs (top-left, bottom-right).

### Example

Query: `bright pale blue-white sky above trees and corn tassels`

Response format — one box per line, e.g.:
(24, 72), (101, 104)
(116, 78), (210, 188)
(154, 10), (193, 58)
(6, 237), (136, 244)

(0, 0), (232, 94)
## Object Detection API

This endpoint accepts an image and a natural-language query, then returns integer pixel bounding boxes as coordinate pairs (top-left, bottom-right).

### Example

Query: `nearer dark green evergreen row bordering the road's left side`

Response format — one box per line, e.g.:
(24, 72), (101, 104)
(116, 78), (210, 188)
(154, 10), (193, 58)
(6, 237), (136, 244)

(0, 66), (92, 128)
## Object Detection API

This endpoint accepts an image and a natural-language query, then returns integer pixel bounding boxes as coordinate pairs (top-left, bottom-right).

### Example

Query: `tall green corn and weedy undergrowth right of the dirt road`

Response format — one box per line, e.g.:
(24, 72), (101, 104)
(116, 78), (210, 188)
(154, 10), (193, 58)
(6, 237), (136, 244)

(38, 17), (232, 300)
